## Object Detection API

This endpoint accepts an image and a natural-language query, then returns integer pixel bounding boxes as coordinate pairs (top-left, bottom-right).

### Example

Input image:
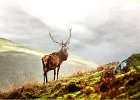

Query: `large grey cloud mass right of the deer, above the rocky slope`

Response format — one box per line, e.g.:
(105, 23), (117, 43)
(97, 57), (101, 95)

(70, 7), (140, 62)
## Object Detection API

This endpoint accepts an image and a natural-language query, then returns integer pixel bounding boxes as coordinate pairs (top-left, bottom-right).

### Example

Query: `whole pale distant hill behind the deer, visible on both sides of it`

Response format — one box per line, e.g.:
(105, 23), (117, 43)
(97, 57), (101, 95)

(0, 38), (98, 89)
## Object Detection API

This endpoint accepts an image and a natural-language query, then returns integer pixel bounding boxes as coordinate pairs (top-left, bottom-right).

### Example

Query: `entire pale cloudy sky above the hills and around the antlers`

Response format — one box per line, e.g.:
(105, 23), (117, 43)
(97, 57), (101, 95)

(0, 0), (140, 63)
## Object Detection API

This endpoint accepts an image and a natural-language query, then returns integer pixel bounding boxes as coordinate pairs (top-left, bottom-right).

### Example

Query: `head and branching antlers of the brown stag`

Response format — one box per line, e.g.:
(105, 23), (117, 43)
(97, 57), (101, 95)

(49, 28), (72, 53)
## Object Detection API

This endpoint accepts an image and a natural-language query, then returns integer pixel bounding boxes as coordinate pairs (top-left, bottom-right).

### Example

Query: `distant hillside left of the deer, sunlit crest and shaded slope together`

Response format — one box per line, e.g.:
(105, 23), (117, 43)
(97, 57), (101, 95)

(0, 38), (43, 90)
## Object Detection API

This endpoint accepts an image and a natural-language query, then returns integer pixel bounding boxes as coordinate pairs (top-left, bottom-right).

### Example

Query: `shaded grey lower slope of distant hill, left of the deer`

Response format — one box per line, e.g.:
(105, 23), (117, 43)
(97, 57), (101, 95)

(0, 51), (43, 90)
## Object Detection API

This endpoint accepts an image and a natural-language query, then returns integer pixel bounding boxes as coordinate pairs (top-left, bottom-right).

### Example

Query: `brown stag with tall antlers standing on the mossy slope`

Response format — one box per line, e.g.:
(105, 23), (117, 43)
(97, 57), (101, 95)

(42, 28), (72, 84)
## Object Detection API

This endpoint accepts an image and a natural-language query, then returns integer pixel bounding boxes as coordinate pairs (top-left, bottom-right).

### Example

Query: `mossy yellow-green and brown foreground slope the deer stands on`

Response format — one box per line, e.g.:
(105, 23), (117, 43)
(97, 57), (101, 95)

(0, 58), (140, 99)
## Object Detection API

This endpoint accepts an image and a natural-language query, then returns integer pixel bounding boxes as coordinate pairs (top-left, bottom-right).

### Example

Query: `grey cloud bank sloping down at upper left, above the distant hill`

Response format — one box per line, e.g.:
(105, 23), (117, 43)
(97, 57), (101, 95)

(0, 0), (50, 47)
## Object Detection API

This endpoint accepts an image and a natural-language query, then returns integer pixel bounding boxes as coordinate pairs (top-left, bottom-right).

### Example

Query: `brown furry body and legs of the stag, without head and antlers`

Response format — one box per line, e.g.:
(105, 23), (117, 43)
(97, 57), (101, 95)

(42, 49), (68, 83)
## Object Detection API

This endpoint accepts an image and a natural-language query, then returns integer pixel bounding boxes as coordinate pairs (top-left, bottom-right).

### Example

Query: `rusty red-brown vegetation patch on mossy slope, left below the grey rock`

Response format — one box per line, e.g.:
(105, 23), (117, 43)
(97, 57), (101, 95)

(94, 67), (120, 99)
